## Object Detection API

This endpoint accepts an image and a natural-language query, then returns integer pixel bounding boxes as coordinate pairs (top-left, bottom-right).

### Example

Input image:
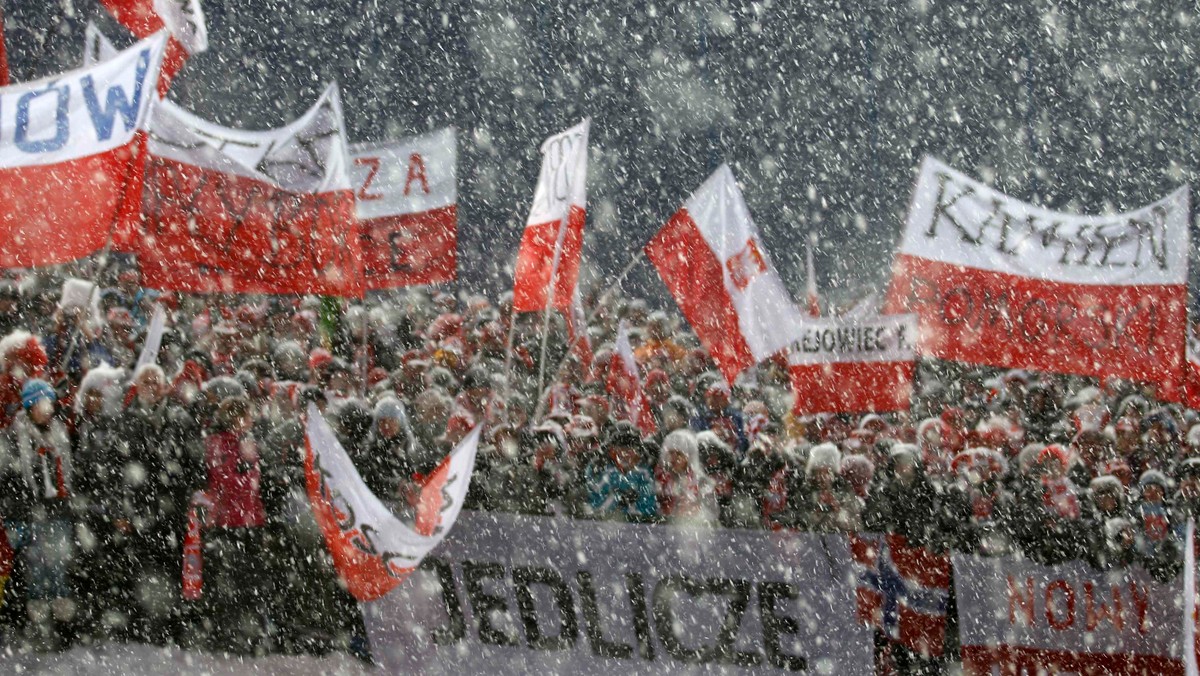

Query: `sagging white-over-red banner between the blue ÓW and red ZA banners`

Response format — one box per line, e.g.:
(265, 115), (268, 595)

(133, 85), (362, 297)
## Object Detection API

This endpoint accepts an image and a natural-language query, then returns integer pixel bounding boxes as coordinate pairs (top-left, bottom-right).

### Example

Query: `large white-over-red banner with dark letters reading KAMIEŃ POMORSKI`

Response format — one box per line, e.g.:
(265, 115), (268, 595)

(884, 157), (1189, 399)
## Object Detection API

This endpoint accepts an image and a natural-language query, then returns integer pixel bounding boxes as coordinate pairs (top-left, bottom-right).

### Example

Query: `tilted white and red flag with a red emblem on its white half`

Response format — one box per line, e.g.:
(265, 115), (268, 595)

(646, 164), (804, 383)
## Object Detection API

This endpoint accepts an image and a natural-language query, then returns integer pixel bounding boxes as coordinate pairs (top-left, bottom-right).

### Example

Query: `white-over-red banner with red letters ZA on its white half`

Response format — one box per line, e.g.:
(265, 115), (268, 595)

(350, 127), (458, 289)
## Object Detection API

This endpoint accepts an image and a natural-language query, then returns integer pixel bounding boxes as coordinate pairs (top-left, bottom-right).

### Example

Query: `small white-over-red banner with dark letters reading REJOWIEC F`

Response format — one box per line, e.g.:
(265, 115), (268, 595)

(787, 315), (917, 415)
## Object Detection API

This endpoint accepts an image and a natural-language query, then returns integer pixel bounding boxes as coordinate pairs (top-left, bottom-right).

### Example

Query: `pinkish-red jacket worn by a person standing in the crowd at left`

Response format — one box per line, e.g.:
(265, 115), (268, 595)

(204, 432), (265, 528)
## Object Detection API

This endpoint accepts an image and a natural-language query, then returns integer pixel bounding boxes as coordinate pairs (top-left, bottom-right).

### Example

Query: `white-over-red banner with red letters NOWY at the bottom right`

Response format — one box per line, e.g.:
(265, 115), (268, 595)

(954, 555), (1183, 675)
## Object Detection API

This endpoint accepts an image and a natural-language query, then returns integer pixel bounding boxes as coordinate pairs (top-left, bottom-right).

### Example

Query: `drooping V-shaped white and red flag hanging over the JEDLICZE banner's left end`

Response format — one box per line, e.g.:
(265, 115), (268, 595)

(304, 403), (482, 600)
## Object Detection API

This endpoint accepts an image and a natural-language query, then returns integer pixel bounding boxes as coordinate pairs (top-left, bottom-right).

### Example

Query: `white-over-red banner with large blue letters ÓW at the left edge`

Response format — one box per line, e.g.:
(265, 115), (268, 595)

(0, 36), (166, 268)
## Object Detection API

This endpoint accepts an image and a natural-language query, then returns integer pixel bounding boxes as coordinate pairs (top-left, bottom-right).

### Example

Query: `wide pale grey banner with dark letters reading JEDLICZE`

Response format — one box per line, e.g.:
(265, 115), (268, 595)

(362, 512), (875, 675)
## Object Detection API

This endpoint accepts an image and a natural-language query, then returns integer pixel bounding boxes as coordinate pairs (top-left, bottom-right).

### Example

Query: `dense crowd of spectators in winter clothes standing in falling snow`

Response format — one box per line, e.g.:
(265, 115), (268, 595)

(0, 268), (1200, 657)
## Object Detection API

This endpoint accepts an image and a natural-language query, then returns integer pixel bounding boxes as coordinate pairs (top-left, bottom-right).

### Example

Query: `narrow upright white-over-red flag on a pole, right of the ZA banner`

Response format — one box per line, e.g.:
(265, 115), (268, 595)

(512, 119), (590, 312)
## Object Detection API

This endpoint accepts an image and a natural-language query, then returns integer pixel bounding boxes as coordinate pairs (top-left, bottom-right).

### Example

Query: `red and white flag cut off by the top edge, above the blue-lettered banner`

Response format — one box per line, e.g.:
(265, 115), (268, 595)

(97, 0), (209, 97)
